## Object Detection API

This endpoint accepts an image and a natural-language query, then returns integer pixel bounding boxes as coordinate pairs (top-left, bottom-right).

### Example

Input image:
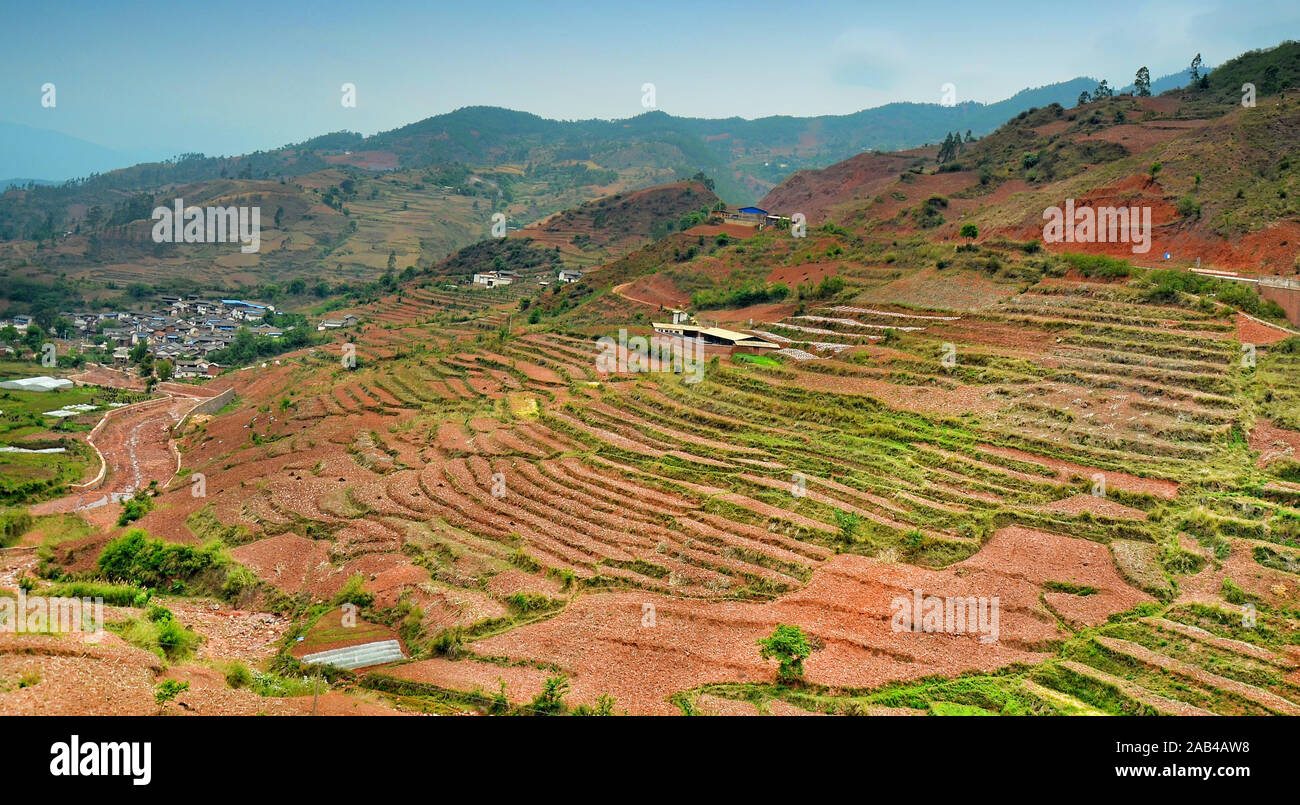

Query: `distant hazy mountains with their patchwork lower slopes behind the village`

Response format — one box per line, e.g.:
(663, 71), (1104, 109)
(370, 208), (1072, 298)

(0, 41), (1258, 321)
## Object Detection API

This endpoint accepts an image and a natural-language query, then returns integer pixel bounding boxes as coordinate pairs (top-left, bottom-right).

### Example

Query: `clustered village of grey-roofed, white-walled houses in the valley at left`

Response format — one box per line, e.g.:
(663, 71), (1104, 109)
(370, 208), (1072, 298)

(0, 295), (359, 377)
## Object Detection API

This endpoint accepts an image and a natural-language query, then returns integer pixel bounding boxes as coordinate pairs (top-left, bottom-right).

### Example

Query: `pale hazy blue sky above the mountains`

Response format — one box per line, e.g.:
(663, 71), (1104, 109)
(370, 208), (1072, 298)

(0, 0), (1300, 153)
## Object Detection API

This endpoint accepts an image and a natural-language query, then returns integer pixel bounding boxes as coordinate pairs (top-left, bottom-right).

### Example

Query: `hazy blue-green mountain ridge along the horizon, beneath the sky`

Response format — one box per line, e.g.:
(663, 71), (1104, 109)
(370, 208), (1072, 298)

(0, 65), (1187, 193)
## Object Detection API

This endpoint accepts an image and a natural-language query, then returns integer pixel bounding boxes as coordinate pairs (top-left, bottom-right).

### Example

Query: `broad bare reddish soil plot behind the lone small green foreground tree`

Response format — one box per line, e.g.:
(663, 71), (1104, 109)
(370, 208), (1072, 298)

(457, 529), (1145, 714)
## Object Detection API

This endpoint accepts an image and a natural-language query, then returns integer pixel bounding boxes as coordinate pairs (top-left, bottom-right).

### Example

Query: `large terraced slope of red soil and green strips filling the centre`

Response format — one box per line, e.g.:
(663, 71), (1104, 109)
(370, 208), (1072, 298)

(22, 247), (1279, 713)
